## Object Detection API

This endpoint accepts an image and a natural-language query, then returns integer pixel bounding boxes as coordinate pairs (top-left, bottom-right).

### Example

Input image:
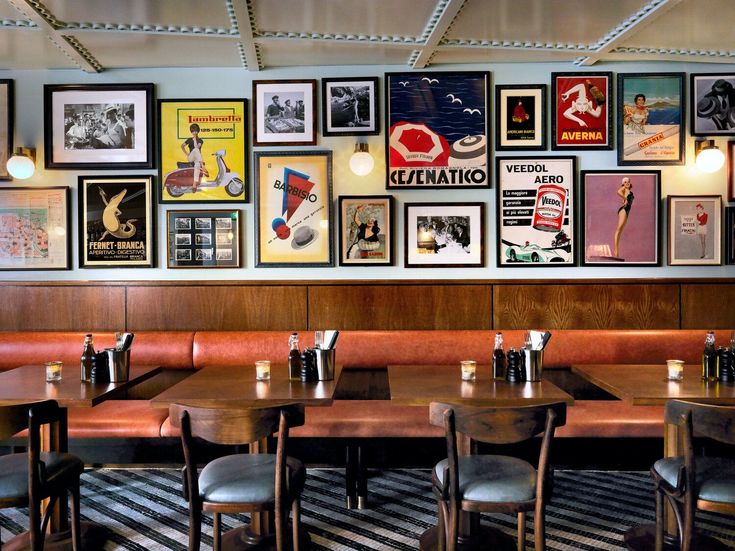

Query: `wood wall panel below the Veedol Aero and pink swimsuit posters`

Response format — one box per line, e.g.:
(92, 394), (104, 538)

(493, 283), (679, 329)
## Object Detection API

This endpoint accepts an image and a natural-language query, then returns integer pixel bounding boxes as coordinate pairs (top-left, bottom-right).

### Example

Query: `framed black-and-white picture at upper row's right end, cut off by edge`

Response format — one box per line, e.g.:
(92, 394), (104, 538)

(689, 73), (735, 136)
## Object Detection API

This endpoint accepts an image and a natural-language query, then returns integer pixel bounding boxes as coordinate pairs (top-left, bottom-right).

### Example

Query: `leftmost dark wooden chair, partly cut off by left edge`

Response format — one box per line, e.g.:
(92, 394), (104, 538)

(0, 400), (84, 551)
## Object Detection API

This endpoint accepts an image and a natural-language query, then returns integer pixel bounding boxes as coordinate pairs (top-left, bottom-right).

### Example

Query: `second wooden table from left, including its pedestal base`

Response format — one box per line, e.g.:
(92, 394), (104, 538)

(151, 365), (342, 550)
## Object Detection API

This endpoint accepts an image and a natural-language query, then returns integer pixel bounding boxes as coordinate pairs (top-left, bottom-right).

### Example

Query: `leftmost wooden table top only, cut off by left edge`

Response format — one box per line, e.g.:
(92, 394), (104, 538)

(0, 365), (161, 407)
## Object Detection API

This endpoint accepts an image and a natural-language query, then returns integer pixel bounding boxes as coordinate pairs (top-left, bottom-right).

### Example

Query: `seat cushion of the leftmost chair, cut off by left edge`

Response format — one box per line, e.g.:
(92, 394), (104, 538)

(0, 452), (84, 500)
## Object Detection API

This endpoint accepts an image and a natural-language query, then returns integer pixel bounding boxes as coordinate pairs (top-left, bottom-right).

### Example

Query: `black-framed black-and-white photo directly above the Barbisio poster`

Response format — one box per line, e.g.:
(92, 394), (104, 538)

(253, 80), (317, 146)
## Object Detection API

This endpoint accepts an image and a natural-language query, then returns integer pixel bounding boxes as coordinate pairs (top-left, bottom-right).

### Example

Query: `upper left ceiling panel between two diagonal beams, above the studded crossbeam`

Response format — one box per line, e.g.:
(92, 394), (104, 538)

(43, 0), (233, 27)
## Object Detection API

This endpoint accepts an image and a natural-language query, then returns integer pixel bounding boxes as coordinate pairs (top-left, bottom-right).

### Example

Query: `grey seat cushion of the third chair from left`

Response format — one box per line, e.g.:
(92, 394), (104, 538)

(434, 455), (536, 503)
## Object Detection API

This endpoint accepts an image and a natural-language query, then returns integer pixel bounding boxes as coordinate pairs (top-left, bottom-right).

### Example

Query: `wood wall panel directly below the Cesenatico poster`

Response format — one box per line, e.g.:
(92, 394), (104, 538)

(308, 284), (492, 330)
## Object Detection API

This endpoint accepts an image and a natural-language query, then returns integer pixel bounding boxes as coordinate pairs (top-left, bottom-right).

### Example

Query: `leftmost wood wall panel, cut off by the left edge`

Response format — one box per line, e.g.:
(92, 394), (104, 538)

(0, 285), (125, 331)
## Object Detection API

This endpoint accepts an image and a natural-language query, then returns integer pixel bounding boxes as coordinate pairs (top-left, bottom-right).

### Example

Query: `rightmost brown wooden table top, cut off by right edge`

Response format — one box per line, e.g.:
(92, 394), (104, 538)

(572, 364), (735, 406)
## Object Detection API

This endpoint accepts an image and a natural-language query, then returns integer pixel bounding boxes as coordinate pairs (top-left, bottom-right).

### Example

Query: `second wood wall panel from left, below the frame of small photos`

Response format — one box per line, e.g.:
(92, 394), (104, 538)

(128, 285), (307, 331)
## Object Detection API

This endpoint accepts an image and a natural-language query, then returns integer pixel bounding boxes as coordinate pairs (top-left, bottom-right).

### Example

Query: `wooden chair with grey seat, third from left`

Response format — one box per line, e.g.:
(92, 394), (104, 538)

(430, 402), (566, 551)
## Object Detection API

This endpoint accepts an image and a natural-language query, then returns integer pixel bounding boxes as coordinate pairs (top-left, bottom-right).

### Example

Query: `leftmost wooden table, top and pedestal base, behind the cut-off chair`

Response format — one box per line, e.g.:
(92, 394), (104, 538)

(0, 365), (161, 551)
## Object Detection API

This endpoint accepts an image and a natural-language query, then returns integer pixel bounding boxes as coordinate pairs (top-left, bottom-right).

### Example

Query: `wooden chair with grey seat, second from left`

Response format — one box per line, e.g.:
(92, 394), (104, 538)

(170, 404), (306, 551)
